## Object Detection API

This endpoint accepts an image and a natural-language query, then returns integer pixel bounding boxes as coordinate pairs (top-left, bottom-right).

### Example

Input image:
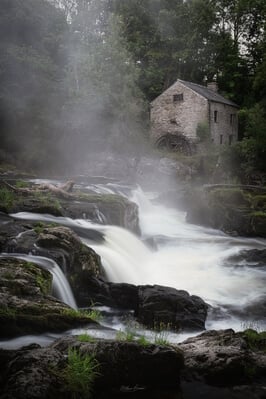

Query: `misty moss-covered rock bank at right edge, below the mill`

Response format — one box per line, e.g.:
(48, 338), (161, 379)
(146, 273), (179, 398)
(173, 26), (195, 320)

(187, 185), (266, 237)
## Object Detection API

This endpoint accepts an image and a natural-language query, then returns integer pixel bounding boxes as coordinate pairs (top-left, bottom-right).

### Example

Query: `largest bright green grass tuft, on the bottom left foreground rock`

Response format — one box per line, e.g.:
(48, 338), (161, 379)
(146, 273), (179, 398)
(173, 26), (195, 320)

(62, 348), (99, 399)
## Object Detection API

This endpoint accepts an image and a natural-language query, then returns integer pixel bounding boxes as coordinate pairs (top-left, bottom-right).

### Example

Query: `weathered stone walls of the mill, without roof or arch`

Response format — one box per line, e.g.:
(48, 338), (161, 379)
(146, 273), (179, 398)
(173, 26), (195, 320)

(150, 81), (238, 144)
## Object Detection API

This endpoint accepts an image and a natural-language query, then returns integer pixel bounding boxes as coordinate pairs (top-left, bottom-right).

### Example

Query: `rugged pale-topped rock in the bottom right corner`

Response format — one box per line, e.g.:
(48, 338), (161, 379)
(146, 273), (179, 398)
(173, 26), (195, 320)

(179, 329), (266, 386)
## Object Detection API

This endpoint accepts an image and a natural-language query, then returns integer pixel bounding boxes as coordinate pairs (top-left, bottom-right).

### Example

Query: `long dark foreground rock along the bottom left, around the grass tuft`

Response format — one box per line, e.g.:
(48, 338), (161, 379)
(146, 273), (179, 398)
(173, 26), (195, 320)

(0, 337), (183, 399)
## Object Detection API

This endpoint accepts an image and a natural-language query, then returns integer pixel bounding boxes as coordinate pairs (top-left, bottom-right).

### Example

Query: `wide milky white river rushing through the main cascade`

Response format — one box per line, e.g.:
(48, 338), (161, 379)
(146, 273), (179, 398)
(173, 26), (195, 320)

(1, 181), (266, 348)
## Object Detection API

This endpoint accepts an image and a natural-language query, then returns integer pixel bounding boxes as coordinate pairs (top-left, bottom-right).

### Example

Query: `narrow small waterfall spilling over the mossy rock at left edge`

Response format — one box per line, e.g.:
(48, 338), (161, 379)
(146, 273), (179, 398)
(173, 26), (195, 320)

(0, 253), (77, 309)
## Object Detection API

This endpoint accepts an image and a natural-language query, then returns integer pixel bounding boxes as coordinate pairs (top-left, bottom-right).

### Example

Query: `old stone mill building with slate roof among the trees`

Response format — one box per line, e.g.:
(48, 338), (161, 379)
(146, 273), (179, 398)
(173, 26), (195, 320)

(150, 79), (238, 149)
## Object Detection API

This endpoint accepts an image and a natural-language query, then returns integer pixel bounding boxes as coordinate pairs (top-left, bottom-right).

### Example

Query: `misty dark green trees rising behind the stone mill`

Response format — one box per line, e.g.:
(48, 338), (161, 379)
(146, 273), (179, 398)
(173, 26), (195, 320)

(0, 0), (266, 176)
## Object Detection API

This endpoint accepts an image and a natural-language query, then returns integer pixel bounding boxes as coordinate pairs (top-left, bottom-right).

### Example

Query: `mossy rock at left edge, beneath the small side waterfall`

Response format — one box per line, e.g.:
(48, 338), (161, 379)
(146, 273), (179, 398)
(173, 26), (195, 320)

(0, 258), (97, 338)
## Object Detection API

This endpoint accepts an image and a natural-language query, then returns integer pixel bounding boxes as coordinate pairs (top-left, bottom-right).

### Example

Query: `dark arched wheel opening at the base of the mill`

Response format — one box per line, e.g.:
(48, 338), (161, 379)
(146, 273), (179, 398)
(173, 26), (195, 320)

(155, 133), (195, 155)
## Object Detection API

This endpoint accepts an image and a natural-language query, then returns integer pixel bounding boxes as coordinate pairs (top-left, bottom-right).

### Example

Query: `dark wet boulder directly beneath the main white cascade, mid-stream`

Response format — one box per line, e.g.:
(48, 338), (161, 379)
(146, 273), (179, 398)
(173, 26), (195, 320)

(75, 277), (208, 331)
